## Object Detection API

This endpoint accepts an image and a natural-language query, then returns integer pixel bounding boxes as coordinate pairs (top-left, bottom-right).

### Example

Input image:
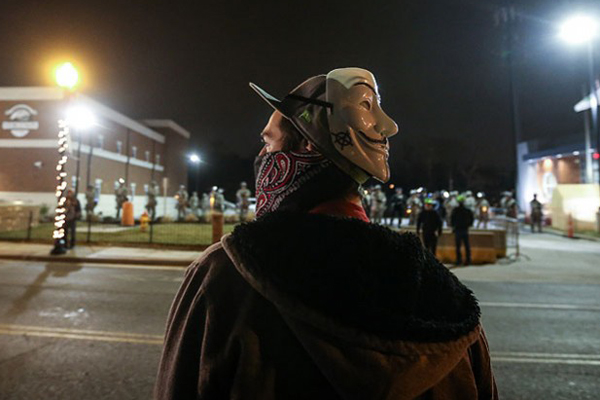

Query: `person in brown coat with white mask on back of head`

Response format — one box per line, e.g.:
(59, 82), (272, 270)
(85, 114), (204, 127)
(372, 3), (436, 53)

(154, 68), (498, 400)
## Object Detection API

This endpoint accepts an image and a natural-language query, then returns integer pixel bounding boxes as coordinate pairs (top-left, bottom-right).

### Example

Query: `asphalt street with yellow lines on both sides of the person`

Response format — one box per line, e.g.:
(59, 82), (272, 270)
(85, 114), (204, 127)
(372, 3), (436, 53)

(0, 234), (600, 399)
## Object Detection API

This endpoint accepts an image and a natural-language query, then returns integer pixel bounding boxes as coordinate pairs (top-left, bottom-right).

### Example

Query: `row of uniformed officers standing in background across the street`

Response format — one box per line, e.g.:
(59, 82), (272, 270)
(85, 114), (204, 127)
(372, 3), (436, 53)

(90, 179), (543, 245)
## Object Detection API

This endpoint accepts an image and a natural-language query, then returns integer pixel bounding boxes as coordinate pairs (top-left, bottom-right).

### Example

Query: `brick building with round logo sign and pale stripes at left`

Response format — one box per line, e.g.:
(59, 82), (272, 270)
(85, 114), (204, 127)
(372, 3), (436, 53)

(0, 87), (190, 217)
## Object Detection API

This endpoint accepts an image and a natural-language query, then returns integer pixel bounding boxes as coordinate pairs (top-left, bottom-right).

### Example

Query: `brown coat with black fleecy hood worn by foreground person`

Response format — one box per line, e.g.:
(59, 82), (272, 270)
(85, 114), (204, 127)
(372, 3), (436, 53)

(155, 214), (498, 400)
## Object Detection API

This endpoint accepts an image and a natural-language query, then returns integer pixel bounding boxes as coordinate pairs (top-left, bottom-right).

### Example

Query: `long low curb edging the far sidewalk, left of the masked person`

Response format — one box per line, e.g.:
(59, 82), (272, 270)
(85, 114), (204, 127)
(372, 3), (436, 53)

(0, 254), (194, 267)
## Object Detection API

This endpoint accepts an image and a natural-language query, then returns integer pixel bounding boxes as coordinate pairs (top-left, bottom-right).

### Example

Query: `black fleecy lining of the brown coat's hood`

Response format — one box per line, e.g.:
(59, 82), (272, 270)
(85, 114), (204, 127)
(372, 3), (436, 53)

(224, 212), (480, 342)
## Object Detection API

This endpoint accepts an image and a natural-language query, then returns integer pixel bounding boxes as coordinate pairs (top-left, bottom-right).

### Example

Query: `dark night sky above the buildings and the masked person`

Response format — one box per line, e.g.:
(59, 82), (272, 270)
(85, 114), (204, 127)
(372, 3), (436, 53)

(0, 0), (600, 193)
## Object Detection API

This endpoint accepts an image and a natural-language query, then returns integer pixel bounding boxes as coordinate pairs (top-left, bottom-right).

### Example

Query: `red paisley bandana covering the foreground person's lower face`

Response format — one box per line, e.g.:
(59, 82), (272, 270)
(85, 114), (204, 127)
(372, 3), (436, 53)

(256, 151), (331, 217)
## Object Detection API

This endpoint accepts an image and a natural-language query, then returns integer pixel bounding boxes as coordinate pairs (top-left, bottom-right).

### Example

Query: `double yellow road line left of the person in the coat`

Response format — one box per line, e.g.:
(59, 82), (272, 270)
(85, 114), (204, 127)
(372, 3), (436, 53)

(0, 324), (163, 345)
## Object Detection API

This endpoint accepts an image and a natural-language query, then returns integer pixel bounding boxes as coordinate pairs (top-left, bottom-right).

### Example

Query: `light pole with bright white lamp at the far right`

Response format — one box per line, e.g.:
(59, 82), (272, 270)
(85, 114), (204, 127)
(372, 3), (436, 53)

(559, 15), (600, 183)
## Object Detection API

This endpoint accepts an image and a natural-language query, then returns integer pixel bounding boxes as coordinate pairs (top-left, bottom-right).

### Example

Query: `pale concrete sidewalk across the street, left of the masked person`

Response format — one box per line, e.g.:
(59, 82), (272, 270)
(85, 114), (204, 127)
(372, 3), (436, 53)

(0, 241), (202, 266)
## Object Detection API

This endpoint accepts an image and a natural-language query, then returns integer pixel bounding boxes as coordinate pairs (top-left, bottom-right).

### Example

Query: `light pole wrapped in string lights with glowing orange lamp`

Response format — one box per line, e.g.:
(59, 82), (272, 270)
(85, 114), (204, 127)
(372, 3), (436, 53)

(50, 62), (79, 255)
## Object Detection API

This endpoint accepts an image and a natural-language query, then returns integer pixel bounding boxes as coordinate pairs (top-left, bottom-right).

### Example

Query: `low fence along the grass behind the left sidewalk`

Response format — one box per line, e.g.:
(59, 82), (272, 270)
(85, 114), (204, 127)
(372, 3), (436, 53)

(0, 211), (239, 247)
